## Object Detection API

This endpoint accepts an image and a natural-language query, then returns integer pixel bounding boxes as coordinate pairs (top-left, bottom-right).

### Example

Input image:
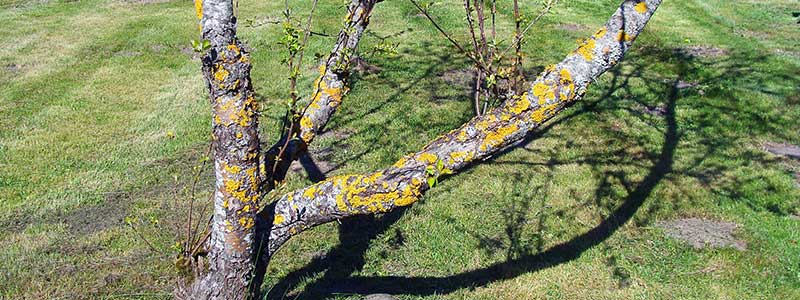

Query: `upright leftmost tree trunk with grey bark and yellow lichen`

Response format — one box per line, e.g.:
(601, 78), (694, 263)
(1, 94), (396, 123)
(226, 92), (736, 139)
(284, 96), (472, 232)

(182, 0), (261, 299)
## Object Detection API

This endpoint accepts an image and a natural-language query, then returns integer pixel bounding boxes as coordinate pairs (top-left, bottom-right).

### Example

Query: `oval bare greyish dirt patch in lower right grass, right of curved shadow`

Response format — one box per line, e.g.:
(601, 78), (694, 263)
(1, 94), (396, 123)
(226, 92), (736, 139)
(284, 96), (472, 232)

(656, 218), (747, 251)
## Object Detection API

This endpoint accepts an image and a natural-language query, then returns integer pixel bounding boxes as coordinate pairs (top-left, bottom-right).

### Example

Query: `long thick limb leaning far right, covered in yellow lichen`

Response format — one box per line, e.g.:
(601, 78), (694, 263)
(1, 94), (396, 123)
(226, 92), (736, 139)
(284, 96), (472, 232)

(260, 0), (662, 257)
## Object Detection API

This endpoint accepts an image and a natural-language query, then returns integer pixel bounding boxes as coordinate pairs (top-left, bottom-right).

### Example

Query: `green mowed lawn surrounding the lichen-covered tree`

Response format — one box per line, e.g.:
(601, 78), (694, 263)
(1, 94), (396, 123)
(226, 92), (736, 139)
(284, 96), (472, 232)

(0, 0), (800, 299)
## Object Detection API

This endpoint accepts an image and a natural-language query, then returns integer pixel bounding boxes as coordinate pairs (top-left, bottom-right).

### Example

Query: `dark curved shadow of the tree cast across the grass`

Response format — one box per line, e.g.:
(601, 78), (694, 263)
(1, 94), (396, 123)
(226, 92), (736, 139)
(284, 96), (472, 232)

(268, 35), (796, 299)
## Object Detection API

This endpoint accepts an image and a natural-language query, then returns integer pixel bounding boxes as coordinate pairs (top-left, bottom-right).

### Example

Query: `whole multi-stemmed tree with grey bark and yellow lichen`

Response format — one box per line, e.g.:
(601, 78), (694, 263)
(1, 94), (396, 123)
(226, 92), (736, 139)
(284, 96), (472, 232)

(176, 0), (661, 299)
